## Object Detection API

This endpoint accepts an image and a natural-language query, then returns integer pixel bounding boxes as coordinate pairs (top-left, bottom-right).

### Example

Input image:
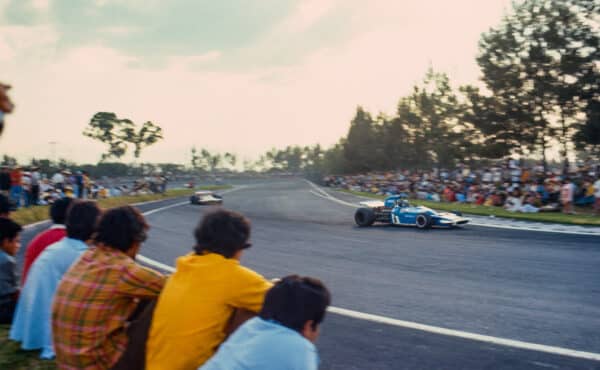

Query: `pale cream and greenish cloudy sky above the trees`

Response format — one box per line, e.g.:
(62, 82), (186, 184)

(0, 0), (511, 163)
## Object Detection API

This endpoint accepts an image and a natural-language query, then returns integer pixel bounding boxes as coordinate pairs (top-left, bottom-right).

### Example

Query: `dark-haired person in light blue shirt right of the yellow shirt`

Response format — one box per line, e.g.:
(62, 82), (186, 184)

(200, 276), (331, 370)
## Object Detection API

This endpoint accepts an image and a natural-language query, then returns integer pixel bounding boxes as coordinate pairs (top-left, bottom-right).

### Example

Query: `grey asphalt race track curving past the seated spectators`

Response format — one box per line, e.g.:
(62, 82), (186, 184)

(17, 180), (600, 370)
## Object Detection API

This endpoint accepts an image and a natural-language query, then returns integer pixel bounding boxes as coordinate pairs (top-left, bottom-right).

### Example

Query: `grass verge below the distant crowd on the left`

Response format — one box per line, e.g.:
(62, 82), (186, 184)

(11, 185), (231, 225)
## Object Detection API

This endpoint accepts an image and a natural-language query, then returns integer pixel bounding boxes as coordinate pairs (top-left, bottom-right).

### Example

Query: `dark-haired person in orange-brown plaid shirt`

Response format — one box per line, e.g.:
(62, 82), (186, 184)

(52, 206), (165, 370)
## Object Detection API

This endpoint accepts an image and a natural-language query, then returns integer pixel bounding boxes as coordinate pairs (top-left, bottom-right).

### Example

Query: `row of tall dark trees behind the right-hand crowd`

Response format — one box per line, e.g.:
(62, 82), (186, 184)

(259, 0), (600, 173)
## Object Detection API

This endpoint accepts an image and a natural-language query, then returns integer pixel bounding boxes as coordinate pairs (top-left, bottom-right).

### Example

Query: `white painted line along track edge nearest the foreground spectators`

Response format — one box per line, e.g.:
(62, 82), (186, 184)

(137, 256), (600, 361)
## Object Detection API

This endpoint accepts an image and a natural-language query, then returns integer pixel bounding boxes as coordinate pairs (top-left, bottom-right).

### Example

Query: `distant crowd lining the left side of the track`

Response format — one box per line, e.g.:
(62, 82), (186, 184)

(0, 166), (168, 208)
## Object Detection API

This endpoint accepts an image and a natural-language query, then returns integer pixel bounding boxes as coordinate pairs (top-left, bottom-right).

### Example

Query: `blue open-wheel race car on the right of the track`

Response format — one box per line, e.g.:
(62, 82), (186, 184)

(354, 195), (469, 229)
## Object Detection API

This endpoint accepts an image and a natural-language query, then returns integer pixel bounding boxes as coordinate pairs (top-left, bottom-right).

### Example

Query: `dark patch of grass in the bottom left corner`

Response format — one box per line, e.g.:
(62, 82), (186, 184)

(0, 325), (56, 370)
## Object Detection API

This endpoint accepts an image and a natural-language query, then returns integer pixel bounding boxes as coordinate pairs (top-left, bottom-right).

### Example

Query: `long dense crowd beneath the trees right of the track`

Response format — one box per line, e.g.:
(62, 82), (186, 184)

(323, 159), (600, 214)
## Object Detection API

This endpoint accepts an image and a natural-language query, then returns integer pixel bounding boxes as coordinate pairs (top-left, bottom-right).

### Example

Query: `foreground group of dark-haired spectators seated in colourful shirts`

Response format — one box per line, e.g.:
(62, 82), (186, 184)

(0, 194), (331, 370)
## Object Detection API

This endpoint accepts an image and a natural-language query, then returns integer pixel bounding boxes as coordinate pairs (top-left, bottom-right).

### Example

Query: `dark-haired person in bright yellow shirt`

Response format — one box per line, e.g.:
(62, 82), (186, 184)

(146, 209), (272, 370)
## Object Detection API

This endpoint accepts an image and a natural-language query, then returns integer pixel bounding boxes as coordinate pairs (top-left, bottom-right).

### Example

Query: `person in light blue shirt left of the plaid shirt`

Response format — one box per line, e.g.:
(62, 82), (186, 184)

(10, 202), (100, 359)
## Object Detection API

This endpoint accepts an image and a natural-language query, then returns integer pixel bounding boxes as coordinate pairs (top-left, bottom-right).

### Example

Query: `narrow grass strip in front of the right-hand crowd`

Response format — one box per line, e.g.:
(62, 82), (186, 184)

(339, 189), (600, 226)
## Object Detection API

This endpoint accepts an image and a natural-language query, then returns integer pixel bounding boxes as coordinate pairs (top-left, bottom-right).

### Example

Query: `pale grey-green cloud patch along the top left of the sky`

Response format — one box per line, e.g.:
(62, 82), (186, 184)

(3, 0), (297, 64)
